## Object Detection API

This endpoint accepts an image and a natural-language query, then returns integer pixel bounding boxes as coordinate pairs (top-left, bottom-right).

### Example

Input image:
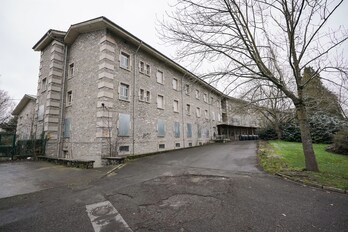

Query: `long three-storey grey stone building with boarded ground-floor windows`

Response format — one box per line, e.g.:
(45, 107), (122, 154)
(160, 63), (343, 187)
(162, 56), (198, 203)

(29, 17), (257, 166)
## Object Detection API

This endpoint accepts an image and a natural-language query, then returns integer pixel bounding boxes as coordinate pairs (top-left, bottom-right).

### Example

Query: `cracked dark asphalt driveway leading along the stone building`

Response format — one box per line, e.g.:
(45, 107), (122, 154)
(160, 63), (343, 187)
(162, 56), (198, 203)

(0, 141), (348, 231)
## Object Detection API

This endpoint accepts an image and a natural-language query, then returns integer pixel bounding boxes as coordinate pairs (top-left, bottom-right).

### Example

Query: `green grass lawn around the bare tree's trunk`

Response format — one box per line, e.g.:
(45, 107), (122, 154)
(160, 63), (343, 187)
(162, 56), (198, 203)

(259, 140), (348, 189)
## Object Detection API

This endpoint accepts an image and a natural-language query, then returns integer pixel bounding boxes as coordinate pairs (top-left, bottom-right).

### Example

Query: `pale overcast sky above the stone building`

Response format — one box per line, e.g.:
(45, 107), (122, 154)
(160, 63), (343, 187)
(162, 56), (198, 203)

(0, 0), (348, 104)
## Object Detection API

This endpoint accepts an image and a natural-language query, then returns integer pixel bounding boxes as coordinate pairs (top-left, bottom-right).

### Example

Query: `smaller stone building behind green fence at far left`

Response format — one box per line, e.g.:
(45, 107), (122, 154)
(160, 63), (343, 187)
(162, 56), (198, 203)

(12, 94), (36, 141)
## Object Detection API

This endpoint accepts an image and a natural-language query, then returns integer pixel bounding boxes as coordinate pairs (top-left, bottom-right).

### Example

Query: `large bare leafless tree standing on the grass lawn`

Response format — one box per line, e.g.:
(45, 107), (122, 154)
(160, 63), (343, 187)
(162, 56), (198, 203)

(161, 0), (348, 171)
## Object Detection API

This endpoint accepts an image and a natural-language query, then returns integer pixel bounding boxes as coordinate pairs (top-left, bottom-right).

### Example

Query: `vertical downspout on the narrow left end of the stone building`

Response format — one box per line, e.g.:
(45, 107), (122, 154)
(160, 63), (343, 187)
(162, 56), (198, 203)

(58, 45), (68, 157)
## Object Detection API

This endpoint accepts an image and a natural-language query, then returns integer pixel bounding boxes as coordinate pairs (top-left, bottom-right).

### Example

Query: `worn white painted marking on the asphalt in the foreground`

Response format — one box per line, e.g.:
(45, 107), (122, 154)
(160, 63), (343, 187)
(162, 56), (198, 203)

(86, 201), (133, 232)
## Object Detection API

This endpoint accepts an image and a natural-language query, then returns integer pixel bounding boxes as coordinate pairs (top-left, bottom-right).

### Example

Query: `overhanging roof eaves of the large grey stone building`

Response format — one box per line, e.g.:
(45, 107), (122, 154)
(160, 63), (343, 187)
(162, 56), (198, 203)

(33, 16), (227, 97)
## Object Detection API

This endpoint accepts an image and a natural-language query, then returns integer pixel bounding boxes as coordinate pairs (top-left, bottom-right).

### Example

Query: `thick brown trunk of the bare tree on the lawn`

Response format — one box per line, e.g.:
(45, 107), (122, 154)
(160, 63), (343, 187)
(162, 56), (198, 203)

(296, 104), (319, 172)
